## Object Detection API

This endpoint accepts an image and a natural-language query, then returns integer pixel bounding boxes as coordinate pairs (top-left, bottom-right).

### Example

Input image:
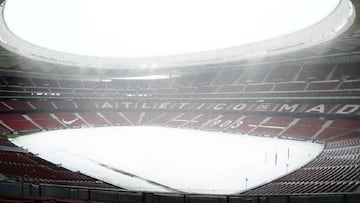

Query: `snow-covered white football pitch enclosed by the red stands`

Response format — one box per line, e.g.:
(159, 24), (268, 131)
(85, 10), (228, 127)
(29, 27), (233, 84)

(12, 126), (323, 194)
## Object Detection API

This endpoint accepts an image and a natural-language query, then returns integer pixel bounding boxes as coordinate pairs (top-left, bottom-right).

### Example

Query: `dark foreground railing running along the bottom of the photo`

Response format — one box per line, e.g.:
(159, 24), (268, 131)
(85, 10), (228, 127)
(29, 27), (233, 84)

(0, 182), (360, 203)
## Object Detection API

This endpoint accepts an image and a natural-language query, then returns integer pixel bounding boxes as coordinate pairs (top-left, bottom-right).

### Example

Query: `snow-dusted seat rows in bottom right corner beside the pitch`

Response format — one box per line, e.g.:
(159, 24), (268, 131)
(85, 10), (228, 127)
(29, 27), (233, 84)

(245, 138), (360, 194)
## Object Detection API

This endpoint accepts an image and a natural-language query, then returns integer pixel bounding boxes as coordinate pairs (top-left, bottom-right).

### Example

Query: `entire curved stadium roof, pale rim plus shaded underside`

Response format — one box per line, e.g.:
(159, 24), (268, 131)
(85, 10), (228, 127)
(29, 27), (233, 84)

(0, 0), (360, 79)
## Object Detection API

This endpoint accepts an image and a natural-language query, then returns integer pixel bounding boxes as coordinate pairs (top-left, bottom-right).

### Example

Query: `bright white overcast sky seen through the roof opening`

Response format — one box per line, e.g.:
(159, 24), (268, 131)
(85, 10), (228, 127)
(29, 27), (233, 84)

(5, 0), (339, 57)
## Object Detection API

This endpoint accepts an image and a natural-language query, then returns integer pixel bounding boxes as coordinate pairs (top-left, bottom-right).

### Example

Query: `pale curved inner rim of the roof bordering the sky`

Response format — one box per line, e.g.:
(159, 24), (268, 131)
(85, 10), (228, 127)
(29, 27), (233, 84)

(0, 0), (356, 70)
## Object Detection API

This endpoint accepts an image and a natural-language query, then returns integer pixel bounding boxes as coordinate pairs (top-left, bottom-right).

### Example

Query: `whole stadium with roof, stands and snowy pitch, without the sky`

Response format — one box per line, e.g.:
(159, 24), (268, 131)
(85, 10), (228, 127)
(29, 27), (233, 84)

(0, 0), (360, 203)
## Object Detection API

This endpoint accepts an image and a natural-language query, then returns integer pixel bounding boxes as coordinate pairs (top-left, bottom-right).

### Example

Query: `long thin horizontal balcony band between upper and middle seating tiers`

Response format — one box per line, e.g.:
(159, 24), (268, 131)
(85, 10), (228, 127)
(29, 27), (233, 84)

(0, 86), (360, 99)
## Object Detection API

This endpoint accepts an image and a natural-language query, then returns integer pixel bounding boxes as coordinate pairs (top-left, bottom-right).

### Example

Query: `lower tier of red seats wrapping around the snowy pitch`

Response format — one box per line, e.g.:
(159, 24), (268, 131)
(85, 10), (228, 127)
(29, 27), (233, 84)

(0, 84), (360, 199)
